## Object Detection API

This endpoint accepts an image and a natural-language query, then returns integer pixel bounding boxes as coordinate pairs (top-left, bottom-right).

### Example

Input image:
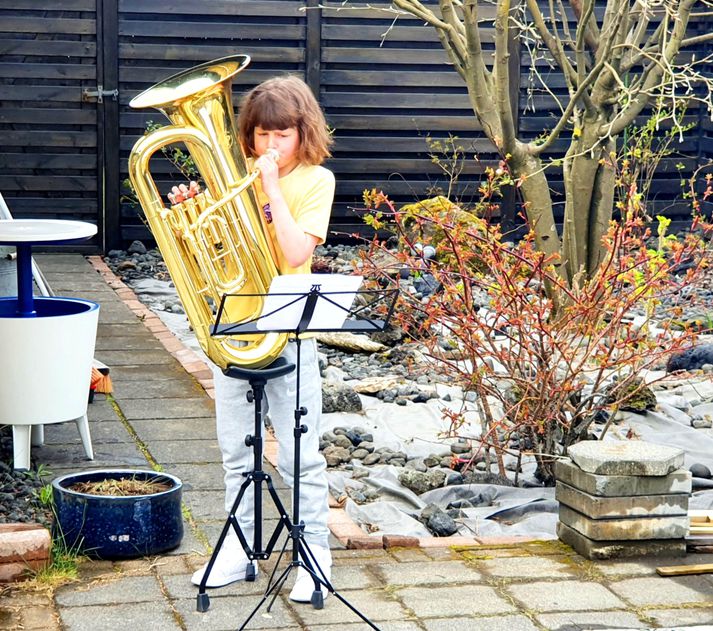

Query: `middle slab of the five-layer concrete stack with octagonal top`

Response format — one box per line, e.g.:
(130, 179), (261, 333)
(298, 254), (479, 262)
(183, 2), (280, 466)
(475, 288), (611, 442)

(555, 482), (688, 519)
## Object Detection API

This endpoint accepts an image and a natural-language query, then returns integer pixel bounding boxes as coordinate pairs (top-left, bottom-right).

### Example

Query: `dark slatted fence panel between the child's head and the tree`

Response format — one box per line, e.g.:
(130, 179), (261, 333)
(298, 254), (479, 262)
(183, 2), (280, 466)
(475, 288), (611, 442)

(320, 1), (495, 233)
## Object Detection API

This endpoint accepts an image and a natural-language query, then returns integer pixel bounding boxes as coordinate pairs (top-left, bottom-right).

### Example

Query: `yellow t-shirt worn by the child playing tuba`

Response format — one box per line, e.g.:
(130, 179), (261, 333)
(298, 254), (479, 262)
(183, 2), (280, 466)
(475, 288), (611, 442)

(255, 164), (334, 274)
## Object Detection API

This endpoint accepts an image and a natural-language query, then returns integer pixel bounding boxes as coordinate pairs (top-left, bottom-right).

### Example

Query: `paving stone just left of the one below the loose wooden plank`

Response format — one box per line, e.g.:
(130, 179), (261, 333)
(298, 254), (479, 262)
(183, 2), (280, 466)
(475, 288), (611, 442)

(504, 580), (626, 612)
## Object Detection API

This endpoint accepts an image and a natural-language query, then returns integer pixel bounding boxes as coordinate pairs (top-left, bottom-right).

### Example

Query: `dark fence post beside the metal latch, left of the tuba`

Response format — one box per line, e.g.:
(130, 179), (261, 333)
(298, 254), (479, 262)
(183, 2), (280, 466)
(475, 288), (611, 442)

(97, 0), (122, 252)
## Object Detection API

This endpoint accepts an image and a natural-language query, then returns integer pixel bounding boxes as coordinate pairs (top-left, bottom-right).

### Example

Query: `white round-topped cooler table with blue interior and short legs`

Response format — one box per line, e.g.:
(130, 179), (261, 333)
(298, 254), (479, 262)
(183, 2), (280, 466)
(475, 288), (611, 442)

(0, 219), (99, 469)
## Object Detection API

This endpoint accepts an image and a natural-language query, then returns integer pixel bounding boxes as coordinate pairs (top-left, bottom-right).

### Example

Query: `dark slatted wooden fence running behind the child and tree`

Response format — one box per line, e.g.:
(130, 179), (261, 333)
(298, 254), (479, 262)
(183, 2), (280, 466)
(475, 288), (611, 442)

(0, 0), (713, 250)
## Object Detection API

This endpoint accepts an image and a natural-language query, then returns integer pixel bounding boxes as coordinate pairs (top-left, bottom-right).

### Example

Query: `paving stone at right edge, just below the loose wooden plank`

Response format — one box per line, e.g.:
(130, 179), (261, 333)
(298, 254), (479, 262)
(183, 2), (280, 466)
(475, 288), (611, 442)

(609, 575), (713, 607)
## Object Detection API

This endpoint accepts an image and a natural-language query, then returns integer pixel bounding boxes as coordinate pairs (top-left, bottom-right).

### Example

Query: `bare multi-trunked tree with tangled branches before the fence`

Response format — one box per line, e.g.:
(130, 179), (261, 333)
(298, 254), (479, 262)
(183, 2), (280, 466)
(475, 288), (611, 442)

(364, 0), (713, 282)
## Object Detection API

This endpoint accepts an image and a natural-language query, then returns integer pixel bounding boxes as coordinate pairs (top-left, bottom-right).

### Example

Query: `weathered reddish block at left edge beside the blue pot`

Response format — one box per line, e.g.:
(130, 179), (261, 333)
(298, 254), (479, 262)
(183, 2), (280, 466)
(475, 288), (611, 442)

(0, 524), (52, 583)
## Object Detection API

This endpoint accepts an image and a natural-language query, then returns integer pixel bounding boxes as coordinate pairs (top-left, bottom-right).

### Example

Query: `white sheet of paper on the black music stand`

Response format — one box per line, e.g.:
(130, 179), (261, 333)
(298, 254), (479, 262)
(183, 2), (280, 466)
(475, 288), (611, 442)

(256, 274), (363, 331)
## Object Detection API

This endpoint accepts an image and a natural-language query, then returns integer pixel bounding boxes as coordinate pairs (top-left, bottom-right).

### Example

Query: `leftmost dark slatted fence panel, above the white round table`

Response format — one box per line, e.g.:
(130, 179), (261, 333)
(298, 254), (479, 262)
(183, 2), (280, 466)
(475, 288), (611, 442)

(0, 0), (98, 233)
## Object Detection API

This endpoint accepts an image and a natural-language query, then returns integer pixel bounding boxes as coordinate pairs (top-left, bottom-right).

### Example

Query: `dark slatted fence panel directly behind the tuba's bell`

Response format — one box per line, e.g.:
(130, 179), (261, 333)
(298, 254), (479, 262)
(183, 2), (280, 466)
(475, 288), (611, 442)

(119, 0), (306, 239)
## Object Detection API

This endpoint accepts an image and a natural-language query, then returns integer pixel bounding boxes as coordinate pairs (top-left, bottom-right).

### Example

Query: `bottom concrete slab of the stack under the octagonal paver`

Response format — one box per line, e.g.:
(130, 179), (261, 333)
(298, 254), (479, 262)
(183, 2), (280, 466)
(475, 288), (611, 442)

(557, 522), (686, 561)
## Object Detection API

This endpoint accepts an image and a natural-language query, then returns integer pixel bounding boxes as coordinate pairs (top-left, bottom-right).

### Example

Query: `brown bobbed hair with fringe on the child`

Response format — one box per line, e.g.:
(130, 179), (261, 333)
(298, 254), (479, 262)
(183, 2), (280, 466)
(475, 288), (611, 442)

(238, 76), (332, 164)
